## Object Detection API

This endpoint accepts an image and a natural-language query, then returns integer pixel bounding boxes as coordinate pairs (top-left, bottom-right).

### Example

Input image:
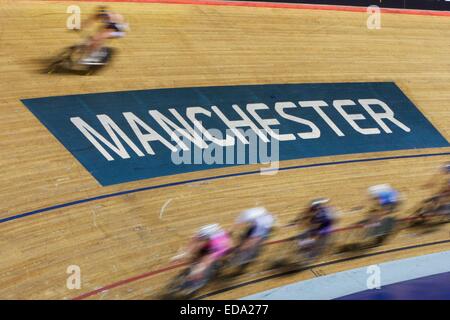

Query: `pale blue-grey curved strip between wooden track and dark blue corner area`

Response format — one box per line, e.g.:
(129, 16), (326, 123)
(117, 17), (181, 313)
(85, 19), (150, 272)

(242, 251), (450, 300)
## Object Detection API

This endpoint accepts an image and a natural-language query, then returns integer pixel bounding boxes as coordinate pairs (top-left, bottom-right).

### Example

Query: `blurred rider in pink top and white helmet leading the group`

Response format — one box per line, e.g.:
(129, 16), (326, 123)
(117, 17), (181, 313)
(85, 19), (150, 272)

(175, 224), (232, 280)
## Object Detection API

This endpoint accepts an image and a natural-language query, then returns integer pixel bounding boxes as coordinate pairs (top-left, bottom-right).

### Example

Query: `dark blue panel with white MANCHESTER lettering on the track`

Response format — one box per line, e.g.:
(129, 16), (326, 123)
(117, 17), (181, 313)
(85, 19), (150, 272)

(22, 82), (449, 186)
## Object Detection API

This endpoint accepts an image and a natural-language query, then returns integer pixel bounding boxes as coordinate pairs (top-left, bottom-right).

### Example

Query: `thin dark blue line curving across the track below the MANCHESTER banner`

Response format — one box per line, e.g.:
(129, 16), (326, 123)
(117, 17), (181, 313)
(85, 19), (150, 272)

(0, 152), (450, 223)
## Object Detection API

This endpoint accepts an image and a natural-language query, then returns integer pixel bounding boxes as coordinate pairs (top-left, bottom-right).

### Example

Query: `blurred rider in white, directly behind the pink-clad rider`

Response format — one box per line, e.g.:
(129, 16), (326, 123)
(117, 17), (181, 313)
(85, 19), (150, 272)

(234, 207), (275, 254)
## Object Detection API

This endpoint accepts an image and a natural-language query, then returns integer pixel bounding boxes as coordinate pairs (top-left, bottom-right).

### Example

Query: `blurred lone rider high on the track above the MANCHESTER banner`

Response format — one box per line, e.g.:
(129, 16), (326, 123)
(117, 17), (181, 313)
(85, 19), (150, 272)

(81, 6), (128, 64)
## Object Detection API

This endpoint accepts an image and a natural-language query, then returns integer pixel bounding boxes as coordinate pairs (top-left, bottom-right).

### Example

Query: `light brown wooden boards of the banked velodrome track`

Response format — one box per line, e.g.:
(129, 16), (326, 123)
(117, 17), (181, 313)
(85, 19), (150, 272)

(0, 0), (450, 299)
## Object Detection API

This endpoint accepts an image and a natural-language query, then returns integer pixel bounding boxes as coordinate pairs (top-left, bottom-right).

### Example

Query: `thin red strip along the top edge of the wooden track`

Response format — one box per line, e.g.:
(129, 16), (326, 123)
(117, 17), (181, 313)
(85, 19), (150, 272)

(50, 0), (450, 17)
